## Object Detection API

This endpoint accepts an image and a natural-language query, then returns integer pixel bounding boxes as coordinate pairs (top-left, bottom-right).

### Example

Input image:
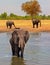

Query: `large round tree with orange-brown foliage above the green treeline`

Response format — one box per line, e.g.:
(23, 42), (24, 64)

(21, 0), (41, 20)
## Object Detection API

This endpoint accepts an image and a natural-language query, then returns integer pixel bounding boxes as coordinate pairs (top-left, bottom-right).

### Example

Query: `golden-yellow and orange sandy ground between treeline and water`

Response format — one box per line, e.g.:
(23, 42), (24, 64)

(0, 20), (50, 32)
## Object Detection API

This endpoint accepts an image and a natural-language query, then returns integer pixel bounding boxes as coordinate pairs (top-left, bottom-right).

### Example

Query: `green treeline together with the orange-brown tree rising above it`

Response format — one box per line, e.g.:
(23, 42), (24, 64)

(0, 0), (50, 20)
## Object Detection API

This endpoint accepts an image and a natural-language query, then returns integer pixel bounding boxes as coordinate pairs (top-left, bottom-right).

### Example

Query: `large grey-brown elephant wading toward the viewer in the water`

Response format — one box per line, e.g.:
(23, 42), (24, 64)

(10, 29), (29, 58)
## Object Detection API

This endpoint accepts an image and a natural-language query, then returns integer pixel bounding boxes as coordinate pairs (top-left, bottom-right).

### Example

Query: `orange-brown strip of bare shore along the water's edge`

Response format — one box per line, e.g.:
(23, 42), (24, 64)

(0, 27), (50, 33)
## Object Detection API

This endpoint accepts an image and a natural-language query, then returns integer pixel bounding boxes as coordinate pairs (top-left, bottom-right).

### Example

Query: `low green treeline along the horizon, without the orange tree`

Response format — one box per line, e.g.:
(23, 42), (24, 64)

(0, 12), (50, 20)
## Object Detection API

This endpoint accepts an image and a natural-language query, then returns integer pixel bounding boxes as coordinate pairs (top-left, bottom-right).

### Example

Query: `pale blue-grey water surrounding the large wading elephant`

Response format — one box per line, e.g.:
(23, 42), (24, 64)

(0, 32), (50, 65)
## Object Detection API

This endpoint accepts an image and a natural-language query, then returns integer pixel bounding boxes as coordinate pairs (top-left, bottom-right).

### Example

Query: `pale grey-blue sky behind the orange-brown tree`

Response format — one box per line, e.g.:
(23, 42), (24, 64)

(0, 0), (50, 16)
